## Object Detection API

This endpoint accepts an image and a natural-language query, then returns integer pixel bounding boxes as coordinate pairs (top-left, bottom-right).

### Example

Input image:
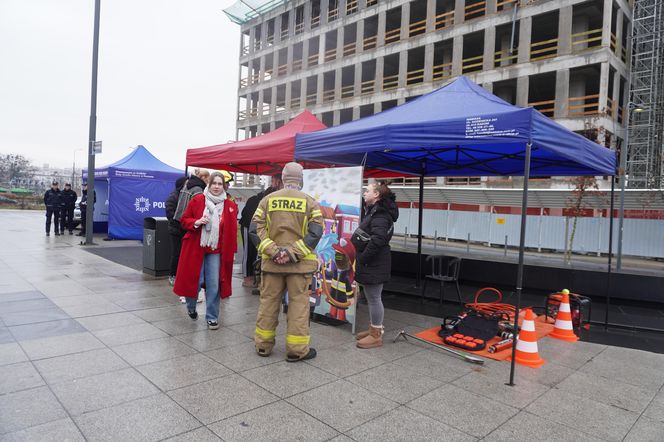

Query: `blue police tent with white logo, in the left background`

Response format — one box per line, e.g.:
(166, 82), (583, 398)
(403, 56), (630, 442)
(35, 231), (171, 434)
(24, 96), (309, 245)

(83, 146), (184, 240)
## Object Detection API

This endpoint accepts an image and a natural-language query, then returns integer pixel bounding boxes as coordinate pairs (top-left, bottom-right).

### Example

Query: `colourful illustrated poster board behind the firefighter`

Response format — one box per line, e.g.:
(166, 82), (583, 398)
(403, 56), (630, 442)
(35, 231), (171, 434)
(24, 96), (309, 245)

(302, 167), (362, 332)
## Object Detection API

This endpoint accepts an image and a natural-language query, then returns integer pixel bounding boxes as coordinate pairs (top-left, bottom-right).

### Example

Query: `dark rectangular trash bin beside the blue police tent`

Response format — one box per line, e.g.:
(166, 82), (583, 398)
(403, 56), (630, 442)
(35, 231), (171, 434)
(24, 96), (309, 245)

(143, 217), (171, 276)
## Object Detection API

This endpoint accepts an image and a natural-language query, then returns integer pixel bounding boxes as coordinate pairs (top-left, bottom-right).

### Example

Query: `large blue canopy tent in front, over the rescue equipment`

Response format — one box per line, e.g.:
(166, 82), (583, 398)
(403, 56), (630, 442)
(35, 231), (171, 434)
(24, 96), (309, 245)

(295, 76), (616, 385)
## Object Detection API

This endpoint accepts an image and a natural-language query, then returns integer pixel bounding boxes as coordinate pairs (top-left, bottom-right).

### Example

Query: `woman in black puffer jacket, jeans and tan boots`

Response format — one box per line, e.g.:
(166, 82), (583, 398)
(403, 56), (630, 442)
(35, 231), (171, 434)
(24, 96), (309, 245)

(351, 183), (399, 348)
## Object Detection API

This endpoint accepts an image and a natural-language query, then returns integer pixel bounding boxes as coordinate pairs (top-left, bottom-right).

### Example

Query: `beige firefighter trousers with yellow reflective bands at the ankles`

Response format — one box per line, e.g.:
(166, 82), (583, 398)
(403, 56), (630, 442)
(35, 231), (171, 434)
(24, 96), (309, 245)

(255, 272), (311, 357)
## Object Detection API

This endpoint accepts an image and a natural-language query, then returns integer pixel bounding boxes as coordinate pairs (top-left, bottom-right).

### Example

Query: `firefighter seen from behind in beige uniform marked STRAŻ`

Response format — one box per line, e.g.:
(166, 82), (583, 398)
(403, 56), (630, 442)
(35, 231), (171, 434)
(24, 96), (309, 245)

(250, 163), (323, 362)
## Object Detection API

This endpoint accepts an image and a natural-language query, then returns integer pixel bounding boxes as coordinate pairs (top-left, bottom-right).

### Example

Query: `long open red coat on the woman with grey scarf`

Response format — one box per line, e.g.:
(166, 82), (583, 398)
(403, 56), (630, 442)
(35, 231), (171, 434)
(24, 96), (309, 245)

(173, 193), (237, 298)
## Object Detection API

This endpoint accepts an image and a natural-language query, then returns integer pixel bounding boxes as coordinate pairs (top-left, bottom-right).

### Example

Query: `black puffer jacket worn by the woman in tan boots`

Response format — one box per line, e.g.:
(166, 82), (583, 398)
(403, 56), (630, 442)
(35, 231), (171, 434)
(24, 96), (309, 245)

(353, 193), (399, 284)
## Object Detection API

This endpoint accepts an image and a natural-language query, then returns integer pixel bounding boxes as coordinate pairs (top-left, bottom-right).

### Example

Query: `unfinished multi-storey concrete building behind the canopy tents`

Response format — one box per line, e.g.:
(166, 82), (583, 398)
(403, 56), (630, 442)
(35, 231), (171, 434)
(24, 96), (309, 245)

(226, 0), (636, 186)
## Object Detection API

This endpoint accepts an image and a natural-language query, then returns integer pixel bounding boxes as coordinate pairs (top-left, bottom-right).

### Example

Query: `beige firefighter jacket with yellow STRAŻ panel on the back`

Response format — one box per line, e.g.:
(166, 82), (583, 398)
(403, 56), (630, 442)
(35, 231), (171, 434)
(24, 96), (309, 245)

(250, 188), (323, 273)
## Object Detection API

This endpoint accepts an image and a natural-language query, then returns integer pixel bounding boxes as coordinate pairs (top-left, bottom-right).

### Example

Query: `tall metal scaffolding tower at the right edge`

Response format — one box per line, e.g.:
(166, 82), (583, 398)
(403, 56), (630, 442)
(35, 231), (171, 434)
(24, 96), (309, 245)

(627, 0), (664, 189)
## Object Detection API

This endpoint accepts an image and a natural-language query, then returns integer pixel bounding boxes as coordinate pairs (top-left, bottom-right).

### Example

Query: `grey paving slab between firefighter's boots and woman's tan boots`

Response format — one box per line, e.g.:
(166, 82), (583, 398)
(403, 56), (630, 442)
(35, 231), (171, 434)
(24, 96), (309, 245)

(307, 339), (385, 377)
